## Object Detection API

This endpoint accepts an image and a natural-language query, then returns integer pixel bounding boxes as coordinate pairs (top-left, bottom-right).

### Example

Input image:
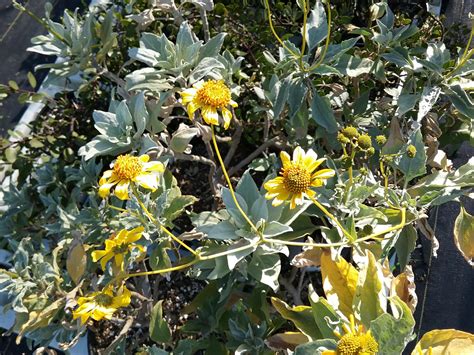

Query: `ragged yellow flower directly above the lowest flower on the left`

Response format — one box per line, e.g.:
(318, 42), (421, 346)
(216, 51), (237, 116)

(91, 227), (145, 270)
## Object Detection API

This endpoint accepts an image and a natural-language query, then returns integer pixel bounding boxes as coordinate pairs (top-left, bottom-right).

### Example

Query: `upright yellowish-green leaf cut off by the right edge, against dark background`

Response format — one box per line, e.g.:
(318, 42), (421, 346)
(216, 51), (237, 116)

(454, 206), (474, 266)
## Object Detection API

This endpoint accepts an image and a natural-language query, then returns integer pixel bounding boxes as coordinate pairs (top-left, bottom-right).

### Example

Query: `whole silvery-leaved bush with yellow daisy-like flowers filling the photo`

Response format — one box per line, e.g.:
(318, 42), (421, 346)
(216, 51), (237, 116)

(0, 0), (474, 355)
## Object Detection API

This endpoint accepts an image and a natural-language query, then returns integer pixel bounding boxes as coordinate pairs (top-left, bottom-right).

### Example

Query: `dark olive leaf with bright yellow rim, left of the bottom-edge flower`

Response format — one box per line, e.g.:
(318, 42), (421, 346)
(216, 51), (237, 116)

(272, 297), (322, 340)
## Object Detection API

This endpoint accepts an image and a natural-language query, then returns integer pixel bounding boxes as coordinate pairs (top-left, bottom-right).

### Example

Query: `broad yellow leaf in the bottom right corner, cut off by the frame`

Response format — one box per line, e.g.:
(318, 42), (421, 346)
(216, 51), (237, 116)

(411, 329), (474, 355)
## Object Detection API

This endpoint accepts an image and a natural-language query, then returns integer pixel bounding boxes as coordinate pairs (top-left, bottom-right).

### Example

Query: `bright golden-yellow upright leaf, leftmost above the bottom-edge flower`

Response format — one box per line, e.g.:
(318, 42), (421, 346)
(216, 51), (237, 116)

(321, 251), (359, 317)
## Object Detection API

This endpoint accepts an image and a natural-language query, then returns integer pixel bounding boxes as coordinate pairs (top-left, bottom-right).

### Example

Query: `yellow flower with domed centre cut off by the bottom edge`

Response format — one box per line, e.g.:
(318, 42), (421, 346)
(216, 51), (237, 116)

(322, 314), (379, 355)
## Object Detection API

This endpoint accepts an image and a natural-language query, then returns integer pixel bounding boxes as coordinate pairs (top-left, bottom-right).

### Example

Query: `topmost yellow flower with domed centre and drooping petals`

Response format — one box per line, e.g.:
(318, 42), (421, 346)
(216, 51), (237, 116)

(180, 80), (237, 129)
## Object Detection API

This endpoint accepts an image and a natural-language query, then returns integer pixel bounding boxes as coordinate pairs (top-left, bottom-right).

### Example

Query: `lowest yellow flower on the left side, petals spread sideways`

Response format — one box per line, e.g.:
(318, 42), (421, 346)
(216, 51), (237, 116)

(72, 286), (131, 324)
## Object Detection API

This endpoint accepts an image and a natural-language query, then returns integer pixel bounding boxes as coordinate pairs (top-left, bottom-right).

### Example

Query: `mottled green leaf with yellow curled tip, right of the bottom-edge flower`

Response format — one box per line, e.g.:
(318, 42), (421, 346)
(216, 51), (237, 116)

(370, 296), (415, 355)
